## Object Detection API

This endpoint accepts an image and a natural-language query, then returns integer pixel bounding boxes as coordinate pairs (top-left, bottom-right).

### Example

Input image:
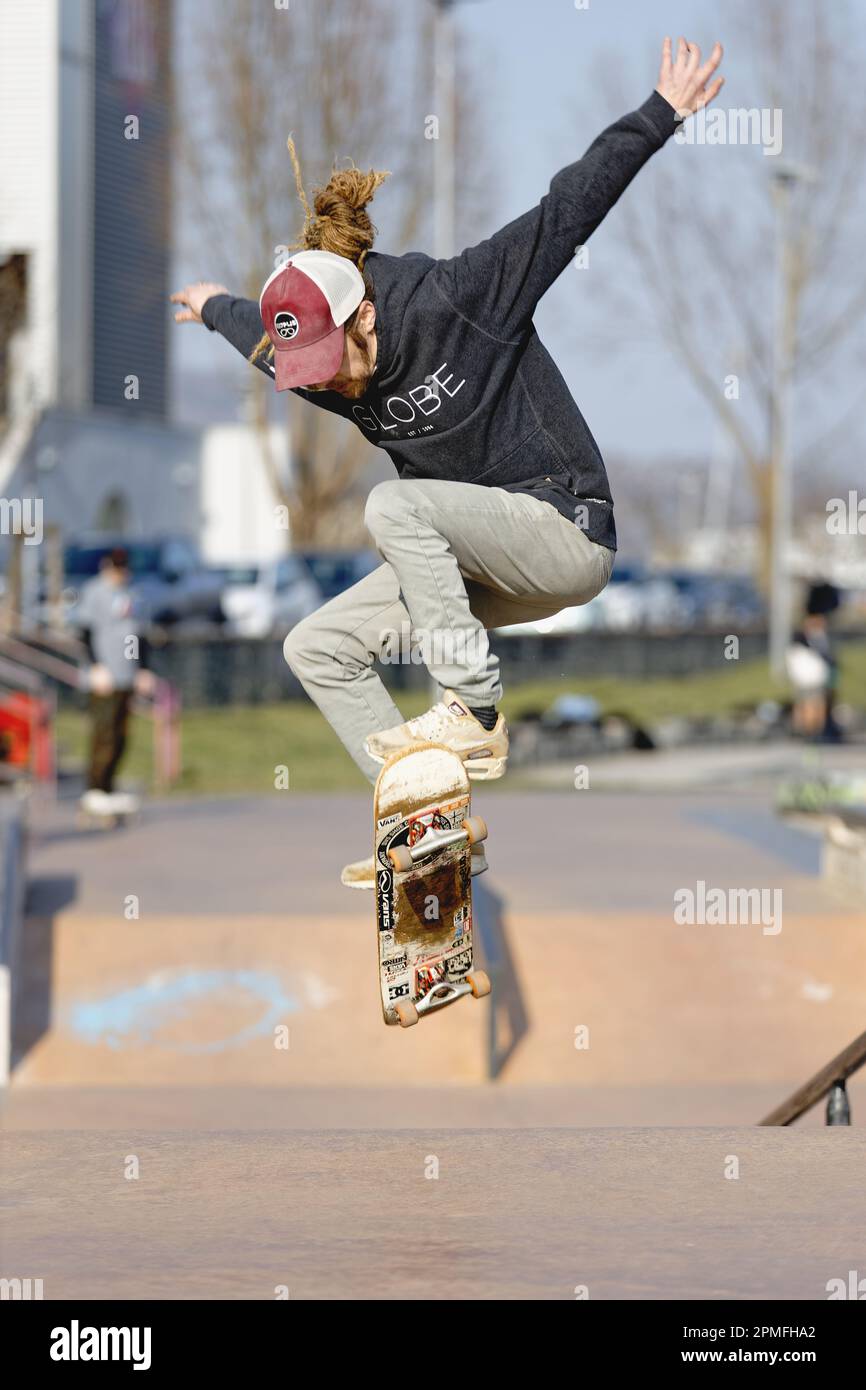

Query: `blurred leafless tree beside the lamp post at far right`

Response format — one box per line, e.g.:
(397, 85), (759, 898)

(572, 0), (866, 571)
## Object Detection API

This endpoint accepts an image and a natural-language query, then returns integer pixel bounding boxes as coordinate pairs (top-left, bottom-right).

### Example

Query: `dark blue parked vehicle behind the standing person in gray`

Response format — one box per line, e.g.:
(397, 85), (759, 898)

(64, 537), (224, 627)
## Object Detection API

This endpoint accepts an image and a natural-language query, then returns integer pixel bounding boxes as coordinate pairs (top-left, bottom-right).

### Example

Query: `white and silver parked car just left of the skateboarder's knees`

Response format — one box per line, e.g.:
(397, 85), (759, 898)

(218, 555), (322, 637)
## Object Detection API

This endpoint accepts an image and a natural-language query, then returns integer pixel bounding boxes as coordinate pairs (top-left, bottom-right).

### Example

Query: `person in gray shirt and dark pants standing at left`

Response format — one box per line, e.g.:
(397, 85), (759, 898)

(76, 548), (154, 813)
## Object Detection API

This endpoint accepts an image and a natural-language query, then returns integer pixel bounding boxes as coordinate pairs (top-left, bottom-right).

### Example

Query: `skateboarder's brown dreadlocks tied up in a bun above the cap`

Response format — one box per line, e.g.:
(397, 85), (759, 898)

(250, 135), (389, 363)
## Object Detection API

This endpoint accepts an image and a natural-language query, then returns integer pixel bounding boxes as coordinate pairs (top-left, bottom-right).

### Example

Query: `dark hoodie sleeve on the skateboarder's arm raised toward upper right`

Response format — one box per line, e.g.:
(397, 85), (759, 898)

(436, 92), (678, 339)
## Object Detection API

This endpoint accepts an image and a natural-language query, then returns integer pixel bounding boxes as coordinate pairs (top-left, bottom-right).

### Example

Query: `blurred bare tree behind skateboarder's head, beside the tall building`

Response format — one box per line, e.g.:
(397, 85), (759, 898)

(177, 0), (494, 545)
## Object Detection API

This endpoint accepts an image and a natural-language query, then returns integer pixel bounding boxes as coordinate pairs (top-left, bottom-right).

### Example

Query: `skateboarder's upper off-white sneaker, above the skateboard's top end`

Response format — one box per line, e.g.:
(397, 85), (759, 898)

(364, 691), (509, 781)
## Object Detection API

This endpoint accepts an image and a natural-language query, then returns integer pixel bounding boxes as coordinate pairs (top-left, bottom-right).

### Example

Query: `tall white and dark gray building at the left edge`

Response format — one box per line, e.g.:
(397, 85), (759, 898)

(0, 0), (202, 592)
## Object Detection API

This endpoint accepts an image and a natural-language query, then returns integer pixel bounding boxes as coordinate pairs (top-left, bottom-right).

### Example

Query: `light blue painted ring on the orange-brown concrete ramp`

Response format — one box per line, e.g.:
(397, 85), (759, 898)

(68, 969), (297, 1054)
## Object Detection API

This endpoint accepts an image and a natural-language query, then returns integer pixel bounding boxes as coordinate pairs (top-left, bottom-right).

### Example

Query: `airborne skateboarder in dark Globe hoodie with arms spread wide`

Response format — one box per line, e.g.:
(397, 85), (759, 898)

(171, 39), (723, 887)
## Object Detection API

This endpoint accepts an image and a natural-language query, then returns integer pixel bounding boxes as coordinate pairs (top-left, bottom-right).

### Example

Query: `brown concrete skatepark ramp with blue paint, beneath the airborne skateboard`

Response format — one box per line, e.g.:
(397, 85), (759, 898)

(1, 794), (866, 1298)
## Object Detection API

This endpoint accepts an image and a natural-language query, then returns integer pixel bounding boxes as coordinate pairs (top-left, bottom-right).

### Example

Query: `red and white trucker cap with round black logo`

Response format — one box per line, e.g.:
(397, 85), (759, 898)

(259, 252), (364, 391)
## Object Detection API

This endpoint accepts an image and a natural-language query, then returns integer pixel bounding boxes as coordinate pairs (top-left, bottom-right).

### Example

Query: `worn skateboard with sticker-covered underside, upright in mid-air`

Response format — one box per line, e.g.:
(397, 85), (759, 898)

(373, 744), (491, 1029)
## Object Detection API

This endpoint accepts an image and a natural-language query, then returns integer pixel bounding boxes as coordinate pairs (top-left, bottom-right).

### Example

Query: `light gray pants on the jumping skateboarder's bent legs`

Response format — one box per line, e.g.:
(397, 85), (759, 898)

(284, 478), (614, 781)
